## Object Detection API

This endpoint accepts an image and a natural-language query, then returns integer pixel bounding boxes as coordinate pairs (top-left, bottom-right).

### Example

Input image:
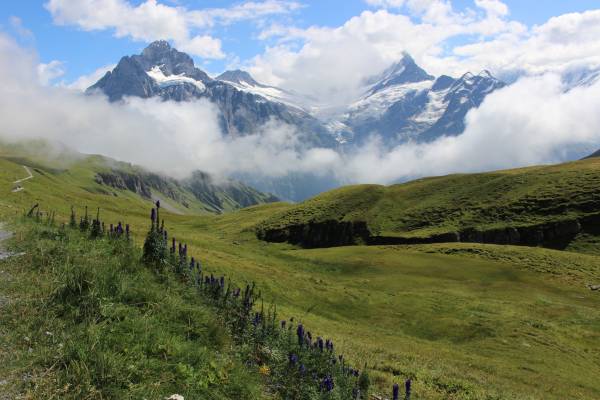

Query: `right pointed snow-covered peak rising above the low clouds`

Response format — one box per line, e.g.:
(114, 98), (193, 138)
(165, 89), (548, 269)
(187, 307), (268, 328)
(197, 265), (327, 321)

(338, 54), (505, 145)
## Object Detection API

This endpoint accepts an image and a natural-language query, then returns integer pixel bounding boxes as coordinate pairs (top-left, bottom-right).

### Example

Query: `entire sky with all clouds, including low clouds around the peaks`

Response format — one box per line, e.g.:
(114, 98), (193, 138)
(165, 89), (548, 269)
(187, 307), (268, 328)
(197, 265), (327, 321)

(0, 0), (600, 189)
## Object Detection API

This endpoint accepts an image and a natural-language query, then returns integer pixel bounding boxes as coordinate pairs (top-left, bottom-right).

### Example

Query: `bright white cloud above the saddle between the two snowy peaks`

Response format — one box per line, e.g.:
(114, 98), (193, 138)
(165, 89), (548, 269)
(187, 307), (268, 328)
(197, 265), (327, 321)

(248, 5), (522, 104)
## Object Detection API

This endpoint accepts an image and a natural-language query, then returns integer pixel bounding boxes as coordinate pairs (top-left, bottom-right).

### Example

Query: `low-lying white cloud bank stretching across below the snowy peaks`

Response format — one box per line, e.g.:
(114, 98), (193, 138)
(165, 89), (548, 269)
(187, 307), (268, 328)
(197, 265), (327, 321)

(0, 34), (600, 187)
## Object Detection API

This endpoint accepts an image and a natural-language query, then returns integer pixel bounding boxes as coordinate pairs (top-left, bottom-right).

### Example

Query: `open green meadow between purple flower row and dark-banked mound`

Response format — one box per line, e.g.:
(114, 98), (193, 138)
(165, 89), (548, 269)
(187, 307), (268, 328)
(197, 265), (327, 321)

(162, 209), (600, 399)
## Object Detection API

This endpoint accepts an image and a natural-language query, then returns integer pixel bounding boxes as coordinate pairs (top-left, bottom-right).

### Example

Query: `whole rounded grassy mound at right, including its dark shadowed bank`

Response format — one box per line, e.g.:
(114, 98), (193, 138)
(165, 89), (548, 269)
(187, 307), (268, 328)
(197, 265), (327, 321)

(258, 158), (600, 251)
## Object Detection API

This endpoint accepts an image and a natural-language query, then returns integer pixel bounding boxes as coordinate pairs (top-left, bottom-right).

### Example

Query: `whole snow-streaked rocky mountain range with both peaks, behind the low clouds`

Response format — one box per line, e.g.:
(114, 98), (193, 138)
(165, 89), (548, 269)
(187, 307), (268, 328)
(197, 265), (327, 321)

(87, 41), (506, 200)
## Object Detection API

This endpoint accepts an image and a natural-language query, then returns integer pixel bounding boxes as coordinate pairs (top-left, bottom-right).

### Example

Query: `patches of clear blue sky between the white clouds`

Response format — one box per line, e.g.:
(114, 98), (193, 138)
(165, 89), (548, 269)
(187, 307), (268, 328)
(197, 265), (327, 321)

(0, 0), (600, 82)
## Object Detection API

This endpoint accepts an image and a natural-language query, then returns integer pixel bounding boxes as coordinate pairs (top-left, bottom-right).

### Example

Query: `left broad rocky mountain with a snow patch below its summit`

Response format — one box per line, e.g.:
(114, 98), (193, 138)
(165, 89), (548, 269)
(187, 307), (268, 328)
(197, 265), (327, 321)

(88, 41), (336, 147)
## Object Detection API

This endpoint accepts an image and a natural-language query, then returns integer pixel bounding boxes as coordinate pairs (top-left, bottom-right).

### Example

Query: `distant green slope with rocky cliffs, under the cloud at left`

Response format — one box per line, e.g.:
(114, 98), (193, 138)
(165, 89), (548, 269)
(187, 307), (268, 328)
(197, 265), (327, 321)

(0, 141), (277, 214)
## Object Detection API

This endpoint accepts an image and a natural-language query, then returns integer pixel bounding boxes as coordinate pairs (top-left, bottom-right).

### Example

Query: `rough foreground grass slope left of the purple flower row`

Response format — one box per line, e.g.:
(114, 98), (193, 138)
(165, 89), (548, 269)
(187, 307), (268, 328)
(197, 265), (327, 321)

(0, 223), (268, 400)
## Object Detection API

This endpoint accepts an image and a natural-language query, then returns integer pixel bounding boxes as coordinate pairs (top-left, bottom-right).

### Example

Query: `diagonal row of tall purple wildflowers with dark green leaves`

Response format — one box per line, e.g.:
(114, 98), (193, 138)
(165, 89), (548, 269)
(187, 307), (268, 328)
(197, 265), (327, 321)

(27, 206), (412, 400)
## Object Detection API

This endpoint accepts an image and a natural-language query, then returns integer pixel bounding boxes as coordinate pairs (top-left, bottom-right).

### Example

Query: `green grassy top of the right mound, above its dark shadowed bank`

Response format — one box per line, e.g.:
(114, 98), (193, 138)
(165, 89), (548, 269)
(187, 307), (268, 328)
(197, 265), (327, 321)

(261, 158), (600, 251)
